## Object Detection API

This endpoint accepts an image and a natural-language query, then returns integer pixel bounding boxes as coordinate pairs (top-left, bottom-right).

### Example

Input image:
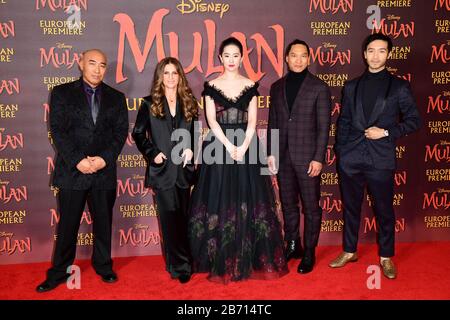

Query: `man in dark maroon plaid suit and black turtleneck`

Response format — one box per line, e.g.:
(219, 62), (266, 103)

(267, 40), (331, 273)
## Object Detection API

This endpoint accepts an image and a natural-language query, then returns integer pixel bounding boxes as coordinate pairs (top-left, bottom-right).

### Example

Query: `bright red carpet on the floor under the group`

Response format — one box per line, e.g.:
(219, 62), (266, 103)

(0, 242), (450, 300)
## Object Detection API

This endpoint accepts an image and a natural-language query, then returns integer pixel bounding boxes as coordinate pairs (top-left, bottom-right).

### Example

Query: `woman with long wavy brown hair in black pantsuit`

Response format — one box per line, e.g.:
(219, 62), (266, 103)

(133, 57), (198, 283)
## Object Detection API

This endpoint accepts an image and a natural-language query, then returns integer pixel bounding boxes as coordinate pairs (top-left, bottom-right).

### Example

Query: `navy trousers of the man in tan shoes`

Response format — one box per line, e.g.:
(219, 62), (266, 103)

(338, 146), (395, 257)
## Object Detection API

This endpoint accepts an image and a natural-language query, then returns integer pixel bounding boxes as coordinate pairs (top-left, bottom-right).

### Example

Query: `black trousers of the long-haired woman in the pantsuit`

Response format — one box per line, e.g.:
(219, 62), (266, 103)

(155, 186), (192, 278)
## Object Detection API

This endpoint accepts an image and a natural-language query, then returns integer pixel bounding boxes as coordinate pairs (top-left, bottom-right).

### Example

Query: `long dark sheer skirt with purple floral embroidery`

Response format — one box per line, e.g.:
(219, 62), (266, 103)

(188, 126), (288, 283)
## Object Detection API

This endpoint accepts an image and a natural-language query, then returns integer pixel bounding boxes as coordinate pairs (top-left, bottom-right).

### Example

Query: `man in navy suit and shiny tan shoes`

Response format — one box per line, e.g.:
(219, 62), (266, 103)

(330, 34), (420, 279)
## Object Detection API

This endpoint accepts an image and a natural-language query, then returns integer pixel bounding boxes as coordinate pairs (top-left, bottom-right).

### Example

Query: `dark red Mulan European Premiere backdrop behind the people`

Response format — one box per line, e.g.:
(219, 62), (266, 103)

(0, 0), (450, 264)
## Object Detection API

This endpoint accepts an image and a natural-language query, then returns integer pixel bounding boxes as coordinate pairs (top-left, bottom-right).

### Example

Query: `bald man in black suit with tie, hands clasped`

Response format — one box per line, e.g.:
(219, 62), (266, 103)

(36, 49), (128, 292)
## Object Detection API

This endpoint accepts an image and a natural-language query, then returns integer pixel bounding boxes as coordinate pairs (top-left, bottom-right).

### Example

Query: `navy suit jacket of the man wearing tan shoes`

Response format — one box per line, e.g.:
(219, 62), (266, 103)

(335, 74), (420, 170)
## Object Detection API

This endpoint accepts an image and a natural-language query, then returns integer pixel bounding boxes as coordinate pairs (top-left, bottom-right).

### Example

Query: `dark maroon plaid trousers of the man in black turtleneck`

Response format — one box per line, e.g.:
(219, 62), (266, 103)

(277, 154), (322, 248)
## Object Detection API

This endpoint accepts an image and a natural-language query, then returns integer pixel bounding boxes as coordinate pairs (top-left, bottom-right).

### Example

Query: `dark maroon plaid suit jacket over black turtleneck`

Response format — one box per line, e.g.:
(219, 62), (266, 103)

(267, 72), (331, 165)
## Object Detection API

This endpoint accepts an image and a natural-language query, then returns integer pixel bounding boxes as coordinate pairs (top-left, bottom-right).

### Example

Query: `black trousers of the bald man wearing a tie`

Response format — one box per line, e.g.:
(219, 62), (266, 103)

(47, 189), (116, 281)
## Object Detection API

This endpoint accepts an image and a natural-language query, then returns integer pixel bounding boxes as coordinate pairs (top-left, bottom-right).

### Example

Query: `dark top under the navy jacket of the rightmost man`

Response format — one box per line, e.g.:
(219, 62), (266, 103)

(361, 68), (389, 121)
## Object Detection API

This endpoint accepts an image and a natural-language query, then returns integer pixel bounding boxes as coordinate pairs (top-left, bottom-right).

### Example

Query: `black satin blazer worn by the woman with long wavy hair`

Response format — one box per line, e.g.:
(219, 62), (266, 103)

(132, 96), (195, 190)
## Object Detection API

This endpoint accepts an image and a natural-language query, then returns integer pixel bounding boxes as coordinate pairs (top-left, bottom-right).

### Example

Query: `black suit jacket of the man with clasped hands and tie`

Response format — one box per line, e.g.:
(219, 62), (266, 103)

(50, 78), (128, 190)
